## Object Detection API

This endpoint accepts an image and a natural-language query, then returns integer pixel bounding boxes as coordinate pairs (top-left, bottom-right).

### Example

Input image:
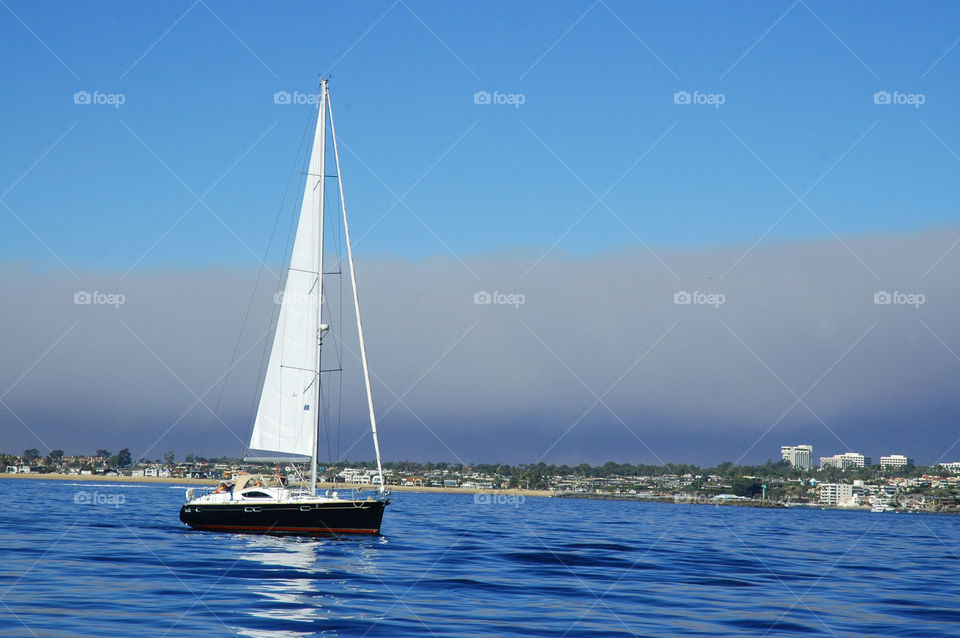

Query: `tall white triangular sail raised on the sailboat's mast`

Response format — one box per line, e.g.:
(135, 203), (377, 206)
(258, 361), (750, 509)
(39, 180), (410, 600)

(250, 100), (326, 456)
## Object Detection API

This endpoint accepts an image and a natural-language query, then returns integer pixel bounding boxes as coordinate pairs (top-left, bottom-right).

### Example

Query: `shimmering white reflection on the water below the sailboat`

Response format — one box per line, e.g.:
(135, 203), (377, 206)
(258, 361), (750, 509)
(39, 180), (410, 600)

(225, 536), (388, 638)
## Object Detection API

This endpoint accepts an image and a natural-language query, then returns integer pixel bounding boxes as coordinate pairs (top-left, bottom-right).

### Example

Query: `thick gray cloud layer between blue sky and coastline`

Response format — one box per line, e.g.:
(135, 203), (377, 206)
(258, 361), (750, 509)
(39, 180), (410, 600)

(0, 229), (960, 464)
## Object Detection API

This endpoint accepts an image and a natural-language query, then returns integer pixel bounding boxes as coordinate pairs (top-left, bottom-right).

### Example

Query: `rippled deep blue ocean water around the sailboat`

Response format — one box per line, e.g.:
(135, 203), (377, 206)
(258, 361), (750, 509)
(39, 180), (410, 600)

(0, 480), (960, 637)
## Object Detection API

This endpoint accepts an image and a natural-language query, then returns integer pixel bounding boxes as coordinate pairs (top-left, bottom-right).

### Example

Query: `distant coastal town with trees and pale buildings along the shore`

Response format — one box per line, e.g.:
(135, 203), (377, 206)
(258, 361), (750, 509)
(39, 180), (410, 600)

(0, 445), (960, 513)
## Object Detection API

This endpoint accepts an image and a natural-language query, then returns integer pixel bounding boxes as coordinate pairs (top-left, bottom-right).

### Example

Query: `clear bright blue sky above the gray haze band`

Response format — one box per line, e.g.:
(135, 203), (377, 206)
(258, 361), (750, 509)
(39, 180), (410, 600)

(0, 0), (960, 271)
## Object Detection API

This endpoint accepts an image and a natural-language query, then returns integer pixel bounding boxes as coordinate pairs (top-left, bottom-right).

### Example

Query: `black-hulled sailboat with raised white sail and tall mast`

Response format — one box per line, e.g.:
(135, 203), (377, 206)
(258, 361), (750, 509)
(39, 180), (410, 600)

(180, 79), (390, 535)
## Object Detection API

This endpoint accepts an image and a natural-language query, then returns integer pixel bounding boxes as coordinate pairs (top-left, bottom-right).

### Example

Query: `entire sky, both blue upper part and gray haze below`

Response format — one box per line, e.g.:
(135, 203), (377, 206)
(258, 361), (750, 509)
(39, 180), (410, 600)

(0, 0), (960, 465)
